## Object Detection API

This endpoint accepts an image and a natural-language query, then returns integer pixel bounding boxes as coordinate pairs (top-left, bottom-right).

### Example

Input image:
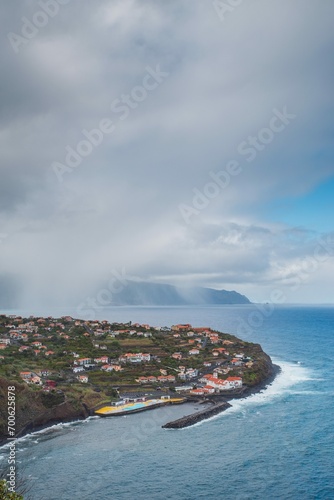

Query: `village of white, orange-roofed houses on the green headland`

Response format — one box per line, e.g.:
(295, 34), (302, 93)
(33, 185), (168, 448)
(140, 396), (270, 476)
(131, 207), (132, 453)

(0, 315), (262, 408)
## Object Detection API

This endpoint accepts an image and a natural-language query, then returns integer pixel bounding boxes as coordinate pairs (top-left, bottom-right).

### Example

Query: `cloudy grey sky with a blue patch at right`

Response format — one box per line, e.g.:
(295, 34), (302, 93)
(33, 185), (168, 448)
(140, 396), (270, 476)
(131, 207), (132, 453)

(0, 0), (334, 307)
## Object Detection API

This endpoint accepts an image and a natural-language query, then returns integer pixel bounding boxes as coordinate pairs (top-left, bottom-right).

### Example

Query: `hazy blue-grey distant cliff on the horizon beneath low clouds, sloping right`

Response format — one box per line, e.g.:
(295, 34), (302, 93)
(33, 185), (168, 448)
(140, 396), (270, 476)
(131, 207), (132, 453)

(108, 281), (250, 306)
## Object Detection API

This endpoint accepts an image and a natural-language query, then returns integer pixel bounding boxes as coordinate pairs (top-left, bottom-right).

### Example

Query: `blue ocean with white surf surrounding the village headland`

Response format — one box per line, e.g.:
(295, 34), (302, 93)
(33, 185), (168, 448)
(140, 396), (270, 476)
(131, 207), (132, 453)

(0, 305), (334, 500)
